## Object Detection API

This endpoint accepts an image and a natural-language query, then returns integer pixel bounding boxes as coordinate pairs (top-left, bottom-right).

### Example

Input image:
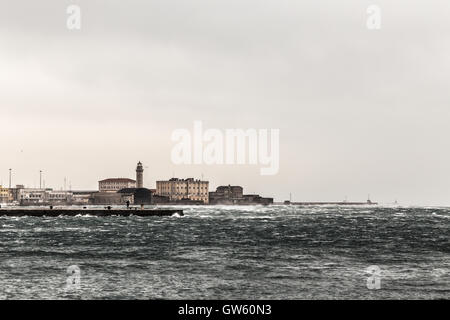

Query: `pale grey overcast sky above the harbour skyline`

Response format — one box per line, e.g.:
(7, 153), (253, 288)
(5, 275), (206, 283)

(0, 0), (450, 205)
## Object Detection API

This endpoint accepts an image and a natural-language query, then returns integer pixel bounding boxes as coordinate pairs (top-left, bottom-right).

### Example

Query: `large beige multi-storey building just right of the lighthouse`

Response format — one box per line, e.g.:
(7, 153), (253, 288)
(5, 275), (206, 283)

(156, 178), (209, 204)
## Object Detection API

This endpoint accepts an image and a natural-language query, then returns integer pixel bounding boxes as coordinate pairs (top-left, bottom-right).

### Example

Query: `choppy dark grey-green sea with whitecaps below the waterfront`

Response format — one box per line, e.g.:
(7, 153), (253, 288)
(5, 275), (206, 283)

(0, 206), (450, 299)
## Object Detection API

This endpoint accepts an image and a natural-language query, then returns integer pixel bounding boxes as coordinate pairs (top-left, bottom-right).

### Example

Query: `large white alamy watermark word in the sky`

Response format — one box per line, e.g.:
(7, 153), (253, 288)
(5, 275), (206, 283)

(171, 121), (280, 175)
